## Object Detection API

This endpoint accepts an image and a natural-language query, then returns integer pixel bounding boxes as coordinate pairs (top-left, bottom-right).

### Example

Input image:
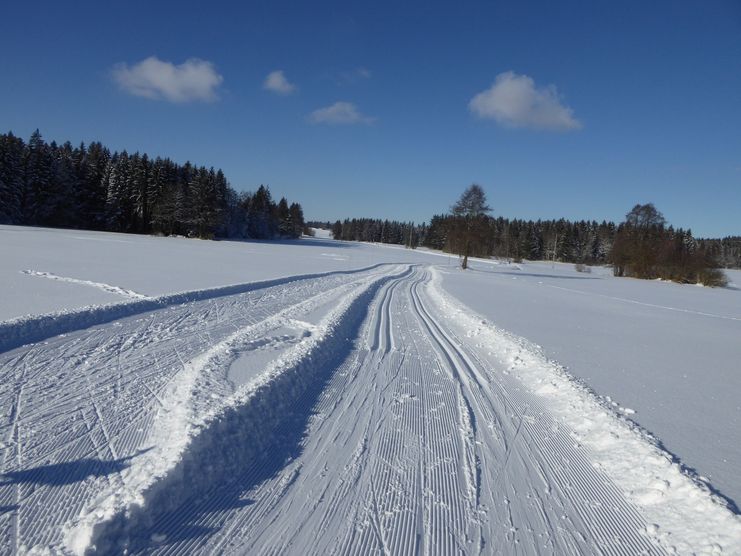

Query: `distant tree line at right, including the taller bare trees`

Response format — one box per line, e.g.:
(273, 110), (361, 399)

(314, 184), (741, 285)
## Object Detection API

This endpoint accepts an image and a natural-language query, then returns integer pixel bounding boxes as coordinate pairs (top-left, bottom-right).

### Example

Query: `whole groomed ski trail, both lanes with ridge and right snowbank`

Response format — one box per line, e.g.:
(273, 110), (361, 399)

(0, 264), (741, 554)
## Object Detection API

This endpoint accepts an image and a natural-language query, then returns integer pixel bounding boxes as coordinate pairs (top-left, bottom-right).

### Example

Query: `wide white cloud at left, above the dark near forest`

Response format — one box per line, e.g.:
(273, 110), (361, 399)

(112, 56), (224, 102)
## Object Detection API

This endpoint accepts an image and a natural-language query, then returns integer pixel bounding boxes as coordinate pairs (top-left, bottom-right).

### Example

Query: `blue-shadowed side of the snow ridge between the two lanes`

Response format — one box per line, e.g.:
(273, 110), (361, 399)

(86, 270), (416, 554)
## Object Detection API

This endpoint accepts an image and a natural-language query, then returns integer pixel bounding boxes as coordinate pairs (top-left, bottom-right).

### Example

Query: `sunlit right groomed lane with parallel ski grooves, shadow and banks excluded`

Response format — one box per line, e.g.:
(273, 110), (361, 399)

(121, 271), (661, 555)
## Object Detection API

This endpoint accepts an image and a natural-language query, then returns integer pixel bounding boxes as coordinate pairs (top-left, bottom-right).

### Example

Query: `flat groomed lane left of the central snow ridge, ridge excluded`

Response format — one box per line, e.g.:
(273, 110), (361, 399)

(0, 266), (402, 552)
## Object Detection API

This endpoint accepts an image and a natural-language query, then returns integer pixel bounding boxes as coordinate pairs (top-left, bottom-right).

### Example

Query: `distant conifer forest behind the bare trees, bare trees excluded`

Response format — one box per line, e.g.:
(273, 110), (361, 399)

(309, 214), (741, 268)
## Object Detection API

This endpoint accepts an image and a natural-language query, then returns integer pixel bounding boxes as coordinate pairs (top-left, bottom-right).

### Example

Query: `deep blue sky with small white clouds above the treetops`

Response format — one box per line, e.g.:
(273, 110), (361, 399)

(0, 0), (741, 236)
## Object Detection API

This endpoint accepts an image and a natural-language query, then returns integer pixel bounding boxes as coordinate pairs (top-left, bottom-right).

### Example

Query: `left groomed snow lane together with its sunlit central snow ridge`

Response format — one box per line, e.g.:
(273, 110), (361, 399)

(0, 265), (400, 553)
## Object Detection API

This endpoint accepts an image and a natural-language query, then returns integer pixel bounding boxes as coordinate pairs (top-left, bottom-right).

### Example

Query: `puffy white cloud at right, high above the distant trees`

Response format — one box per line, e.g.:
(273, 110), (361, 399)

(468, 71), (582, 131)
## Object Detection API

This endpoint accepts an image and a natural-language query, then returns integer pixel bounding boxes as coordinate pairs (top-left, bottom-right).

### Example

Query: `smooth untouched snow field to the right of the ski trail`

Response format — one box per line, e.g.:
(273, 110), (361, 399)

(436, 262), (741, 501)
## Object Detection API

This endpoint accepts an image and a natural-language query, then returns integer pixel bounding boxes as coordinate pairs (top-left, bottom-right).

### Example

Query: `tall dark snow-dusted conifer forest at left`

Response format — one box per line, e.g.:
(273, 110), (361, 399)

(0, 130), (304, 239)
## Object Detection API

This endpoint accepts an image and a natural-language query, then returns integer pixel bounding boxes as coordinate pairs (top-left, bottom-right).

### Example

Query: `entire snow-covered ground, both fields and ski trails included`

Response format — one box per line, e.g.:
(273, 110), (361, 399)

(0, 227), (741, 554)
